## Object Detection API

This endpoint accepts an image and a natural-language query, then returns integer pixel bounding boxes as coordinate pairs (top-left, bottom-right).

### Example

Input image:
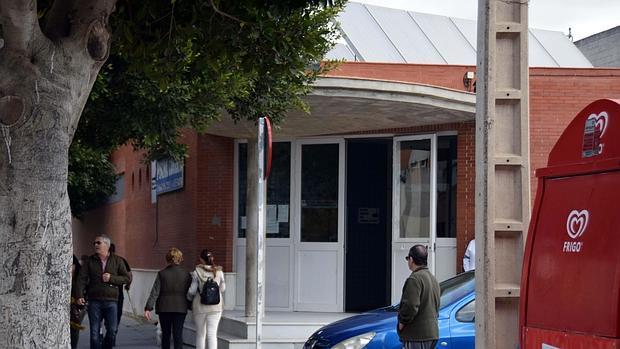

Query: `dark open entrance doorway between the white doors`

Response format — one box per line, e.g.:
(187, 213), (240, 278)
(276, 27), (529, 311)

(345, 139), (392, 312)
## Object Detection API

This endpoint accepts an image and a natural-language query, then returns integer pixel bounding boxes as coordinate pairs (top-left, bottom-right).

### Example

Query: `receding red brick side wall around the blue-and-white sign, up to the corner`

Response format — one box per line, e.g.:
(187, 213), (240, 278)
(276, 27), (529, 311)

(79, 132), (205, 269)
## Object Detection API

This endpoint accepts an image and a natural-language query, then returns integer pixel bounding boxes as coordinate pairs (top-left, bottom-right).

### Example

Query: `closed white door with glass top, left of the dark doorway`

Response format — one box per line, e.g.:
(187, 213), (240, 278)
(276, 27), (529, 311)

(294, 139), (344, 312)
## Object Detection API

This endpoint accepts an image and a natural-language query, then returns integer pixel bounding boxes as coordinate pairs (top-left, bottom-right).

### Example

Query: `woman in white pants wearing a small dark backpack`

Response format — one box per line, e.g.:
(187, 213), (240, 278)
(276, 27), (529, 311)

(187, 249), (226, 349)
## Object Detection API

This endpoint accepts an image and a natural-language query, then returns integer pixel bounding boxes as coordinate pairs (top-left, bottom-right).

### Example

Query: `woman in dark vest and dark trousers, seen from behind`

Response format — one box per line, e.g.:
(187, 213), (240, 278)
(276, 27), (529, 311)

(144, 247), (192, 349)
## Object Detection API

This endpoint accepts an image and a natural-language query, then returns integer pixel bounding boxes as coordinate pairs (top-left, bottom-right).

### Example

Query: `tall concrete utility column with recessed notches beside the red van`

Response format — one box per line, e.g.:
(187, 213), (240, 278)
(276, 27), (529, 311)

(476, 0), (530, 349)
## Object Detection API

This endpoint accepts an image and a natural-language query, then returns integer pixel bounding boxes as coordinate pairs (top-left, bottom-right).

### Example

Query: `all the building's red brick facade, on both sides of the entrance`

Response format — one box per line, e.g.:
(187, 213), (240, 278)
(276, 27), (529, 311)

(74, 63), (620, 271)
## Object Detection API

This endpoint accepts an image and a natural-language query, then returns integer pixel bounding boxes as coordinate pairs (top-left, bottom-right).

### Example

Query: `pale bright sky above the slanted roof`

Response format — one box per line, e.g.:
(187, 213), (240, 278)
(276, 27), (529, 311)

(350, 0), (620, 41)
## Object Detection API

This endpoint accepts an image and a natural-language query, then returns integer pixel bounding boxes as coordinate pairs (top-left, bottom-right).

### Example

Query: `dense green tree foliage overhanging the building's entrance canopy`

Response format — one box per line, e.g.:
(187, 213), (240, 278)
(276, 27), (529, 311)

(61, 0), (345, 212)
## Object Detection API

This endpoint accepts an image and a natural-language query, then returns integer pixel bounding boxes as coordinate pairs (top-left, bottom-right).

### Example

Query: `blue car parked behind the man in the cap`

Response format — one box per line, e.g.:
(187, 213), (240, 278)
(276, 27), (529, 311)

(304, 271), (476, 349)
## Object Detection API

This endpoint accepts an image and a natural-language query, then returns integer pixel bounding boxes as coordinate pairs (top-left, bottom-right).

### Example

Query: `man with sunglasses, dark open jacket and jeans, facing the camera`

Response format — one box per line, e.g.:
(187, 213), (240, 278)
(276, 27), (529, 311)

(73, 235), (129, 349)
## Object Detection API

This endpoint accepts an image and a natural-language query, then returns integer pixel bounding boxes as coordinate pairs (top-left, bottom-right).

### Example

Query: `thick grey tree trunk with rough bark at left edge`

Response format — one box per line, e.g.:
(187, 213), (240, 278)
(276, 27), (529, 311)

(0, 0), (114, 348)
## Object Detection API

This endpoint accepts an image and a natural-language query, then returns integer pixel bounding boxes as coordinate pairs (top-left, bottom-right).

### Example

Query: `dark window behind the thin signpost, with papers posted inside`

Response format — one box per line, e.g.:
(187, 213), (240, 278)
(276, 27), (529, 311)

(237, 142), (291, 238)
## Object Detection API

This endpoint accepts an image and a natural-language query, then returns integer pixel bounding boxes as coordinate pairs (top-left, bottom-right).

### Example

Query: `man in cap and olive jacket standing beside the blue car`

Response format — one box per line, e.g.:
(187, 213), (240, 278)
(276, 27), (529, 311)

(398, 245), (440, 349)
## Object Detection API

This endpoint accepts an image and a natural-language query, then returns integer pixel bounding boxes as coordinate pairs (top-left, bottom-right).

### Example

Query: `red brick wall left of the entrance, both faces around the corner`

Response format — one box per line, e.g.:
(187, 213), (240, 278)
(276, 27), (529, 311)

(74, 132), (234, 270)
